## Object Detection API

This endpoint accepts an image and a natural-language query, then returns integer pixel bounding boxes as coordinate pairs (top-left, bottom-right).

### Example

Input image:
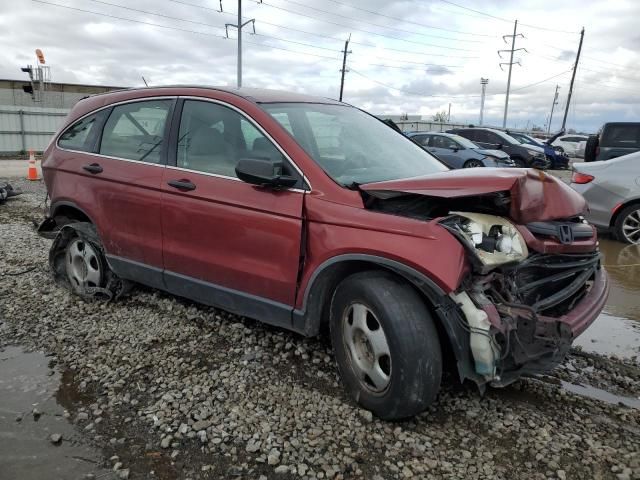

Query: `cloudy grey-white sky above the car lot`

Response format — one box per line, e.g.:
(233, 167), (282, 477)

(0, 0), (640, 131)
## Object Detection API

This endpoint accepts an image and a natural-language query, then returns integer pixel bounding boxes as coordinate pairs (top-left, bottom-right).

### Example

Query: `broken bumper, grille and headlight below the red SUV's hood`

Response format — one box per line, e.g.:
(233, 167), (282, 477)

(440, 212), (608, 386)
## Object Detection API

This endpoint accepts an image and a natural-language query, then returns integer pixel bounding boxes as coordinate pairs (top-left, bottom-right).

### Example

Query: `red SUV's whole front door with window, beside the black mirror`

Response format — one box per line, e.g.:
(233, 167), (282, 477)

(162, 99), (304, 326)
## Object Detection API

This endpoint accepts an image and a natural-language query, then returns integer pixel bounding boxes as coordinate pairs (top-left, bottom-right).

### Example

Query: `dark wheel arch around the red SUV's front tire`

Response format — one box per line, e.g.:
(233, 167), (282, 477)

(304, 260), (456, 366)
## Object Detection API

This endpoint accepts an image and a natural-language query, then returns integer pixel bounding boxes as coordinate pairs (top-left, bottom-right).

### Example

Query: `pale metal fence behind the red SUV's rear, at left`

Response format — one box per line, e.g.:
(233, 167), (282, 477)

(0, 106), (69, 155)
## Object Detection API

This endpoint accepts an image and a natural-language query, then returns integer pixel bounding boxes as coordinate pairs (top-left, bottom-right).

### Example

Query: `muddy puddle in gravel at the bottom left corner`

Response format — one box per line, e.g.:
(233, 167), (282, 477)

(0, 347), (108, 480)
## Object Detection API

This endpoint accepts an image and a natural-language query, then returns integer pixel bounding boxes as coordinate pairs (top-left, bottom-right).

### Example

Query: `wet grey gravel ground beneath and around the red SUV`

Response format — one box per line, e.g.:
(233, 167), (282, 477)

(0, 181), (640, 480)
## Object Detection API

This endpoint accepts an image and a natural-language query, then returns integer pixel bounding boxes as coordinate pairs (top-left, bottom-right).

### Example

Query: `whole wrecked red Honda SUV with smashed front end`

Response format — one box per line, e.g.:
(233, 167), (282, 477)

(40, 87), (608, 419)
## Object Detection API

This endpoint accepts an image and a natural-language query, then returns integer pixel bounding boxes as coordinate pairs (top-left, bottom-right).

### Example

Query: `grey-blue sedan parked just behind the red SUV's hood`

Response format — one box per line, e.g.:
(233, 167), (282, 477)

(406, 132), (515, 168)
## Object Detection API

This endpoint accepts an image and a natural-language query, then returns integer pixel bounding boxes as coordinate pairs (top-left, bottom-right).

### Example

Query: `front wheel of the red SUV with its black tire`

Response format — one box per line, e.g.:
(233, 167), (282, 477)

(330, 271), (442, 420)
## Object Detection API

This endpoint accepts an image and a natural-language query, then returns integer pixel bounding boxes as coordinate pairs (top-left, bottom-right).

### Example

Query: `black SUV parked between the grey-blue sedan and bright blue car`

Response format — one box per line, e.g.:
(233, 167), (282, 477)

(447, 128), (549, 170)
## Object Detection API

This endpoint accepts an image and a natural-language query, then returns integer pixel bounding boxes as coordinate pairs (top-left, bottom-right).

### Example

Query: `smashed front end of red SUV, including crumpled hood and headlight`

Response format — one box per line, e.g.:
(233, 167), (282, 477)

(360, 169), (608, 386)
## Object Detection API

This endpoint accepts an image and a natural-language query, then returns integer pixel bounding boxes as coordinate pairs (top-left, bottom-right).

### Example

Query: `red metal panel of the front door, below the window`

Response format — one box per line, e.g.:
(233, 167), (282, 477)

(162, 168), (304, 305)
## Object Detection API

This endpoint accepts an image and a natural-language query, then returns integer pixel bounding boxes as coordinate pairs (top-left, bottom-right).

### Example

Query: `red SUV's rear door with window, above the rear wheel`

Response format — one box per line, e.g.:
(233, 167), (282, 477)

(58, 98), (175, 287)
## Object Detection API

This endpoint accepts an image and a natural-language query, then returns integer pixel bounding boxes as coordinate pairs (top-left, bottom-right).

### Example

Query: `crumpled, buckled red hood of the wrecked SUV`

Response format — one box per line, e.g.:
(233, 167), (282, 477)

(360, 168), (587, 224)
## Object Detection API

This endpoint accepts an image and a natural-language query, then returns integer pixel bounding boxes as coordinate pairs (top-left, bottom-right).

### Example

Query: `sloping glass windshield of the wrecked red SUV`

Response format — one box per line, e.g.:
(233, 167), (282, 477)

(261, 103), (448, 185)
